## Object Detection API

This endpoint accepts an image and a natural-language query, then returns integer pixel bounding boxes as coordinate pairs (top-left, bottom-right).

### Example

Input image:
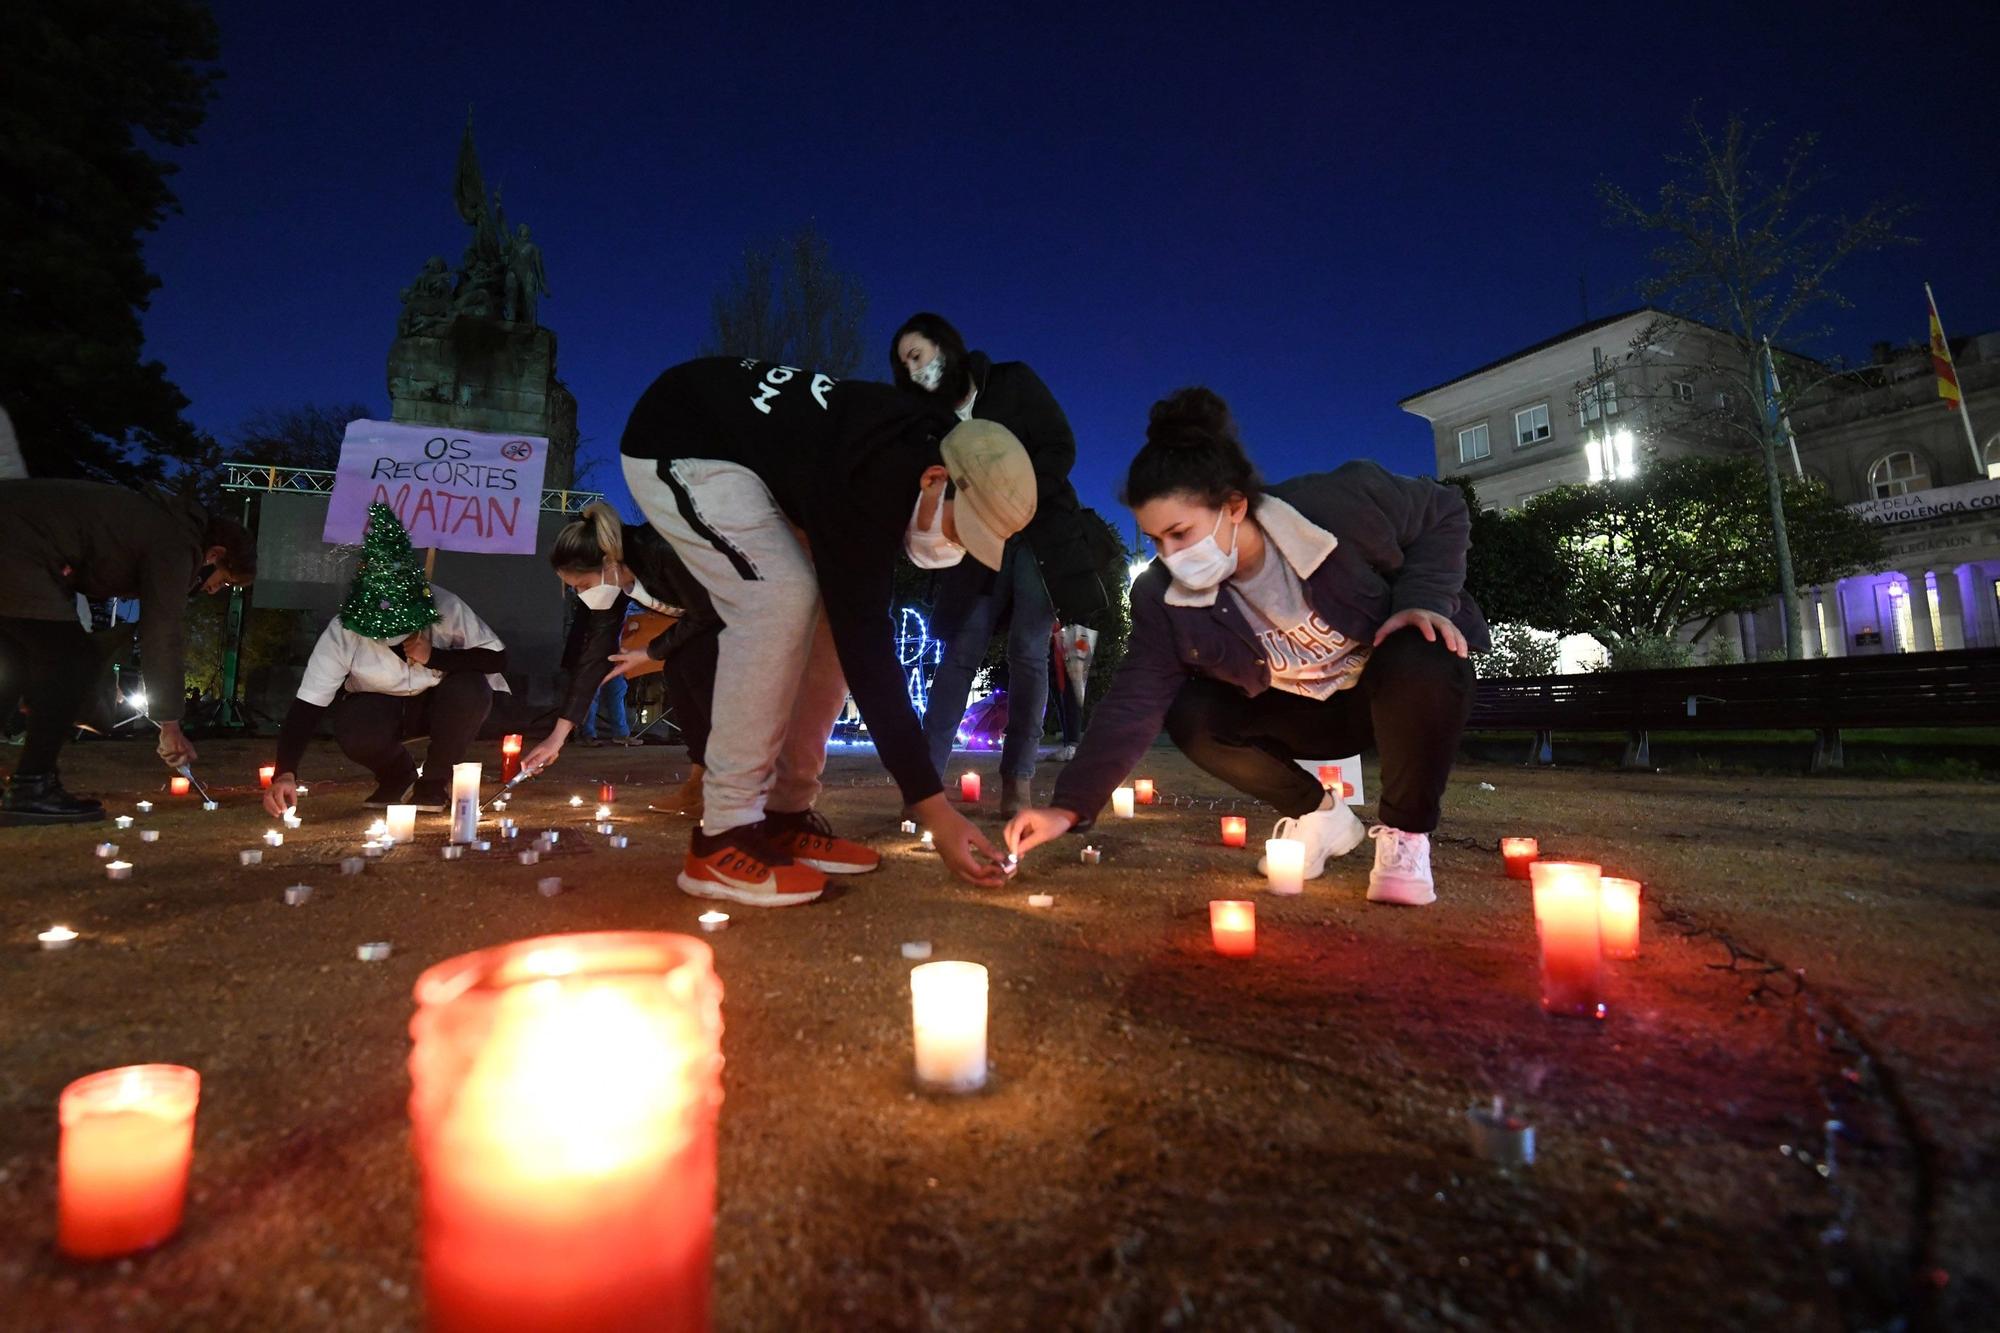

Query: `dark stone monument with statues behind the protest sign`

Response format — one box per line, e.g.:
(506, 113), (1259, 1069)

(388, 110), (576, 488)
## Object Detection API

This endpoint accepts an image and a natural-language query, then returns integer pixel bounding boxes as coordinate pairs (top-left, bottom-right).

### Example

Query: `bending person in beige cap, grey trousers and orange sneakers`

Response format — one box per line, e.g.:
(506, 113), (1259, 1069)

(620, 356), (1034, 907)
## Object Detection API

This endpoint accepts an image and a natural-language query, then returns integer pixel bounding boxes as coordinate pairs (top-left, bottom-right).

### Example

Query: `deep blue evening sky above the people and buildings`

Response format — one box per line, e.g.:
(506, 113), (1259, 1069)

(146, 2), (2000, 526)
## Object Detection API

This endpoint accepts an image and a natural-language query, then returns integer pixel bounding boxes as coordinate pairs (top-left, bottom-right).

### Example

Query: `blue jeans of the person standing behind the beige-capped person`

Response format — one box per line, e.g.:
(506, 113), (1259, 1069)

(924, 538), (1056, 779)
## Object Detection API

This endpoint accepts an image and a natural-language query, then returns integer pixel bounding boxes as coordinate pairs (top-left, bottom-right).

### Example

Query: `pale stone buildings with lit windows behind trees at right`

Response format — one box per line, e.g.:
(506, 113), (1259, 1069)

(1400, 308), (2000, 660)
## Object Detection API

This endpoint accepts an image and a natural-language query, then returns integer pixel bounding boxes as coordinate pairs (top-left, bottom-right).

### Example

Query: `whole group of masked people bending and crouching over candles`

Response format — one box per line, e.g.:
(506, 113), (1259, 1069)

(0, 314), (1490, 907)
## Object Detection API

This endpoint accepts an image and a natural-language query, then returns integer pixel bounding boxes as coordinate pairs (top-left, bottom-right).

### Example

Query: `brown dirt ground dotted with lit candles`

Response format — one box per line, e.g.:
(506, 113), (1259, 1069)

(0, 743), (2000, 1331)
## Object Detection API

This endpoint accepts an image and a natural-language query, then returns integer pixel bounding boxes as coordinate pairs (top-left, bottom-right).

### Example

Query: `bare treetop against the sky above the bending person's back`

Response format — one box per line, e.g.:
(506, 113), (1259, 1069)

(702, 222), (868, 374)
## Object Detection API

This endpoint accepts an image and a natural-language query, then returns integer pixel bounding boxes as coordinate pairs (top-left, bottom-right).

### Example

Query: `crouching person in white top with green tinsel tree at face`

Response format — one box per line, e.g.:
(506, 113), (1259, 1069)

(264, 504), (506, 815)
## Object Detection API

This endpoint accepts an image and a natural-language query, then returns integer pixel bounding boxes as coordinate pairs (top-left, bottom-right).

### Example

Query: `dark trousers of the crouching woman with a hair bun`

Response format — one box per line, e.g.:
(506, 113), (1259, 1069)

(1166, 628), (1472, 833)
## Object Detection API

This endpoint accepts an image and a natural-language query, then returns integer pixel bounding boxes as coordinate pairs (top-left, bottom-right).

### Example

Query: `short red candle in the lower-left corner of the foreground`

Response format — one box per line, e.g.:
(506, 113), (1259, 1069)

(56, 1065), (202, 1259)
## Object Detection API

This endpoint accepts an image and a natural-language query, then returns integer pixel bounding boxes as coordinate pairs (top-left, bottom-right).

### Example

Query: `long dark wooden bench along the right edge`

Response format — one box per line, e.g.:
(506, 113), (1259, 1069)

(1466, 648), (2000, 773)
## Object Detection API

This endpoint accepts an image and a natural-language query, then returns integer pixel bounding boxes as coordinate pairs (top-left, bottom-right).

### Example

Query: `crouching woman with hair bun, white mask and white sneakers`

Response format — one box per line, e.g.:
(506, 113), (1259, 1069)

(1006, 388), (1492, 907)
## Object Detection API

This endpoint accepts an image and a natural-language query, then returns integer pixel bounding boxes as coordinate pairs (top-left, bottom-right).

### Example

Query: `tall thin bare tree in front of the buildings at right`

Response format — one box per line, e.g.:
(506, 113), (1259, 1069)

(1598, 108), (1912, 658)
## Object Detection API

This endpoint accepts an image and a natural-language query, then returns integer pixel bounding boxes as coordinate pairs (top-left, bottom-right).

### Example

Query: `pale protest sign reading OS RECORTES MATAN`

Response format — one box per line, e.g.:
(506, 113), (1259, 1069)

(322, 420), (548, 554)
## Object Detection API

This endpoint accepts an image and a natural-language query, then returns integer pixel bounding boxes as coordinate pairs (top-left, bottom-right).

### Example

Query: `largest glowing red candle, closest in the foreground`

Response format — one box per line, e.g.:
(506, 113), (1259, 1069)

(410, 933), (722, 1333)
